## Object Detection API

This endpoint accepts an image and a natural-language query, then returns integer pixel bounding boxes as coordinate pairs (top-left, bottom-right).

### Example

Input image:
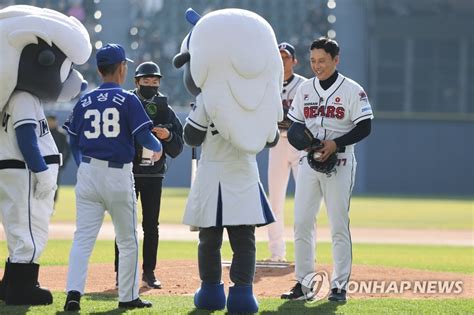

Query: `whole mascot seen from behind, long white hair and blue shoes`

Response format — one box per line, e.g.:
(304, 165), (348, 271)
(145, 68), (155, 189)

(173, 9), (283, 313)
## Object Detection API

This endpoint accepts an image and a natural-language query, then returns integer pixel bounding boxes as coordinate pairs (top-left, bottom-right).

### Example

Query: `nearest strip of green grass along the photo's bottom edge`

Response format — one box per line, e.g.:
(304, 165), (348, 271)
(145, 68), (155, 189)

(0, 293), (474, 315)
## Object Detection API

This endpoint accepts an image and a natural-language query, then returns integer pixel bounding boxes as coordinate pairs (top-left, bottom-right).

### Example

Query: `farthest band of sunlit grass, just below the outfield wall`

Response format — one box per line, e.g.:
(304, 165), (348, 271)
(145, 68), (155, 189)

(52, 186), (474, 230)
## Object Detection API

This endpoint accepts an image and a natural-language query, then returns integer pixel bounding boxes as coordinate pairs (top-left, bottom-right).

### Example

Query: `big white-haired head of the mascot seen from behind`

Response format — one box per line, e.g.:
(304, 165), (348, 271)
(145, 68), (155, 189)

(173, 9), (283, 153)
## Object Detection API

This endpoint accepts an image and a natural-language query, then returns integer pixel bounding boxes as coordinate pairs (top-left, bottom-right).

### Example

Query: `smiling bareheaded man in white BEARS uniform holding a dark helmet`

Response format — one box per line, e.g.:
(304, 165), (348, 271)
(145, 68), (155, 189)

(282, 37), (374, 301)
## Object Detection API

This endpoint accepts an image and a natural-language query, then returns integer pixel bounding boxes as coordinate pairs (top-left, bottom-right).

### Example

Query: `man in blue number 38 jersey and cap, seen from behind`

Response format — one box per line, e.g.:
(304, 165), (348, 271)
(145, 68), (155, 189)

(64, 44), (162, 311)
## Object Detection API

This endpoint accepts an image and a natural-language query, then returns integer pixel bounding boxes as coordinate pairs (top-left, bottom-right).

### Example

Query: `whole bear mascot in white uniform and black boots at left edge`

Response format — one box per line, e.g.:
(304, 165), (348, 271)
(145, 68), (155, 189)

(0, 5), (92, 305)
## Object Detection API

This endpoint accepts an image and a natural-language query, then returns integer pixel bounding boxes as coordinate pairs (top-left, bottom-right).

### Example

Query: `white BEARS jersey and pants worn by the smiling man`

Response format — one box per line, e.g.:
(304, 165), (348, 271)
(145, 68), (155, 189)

(288, 74), (374, 289)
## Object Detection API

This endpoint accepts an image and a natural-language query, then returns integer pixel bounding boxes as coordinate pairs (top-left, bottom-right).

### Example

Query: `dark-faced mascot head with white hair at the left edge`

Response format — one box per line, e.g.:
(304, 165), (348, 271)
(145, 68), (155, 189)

(0, 5), (92, 110)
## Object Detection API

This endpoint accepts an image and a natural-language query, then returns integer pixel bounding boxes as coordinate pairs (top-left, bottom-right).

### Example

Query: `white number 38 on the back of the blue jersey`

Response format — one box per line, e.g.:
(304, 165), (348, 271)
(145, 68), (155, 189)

(84, 107), (120, 139)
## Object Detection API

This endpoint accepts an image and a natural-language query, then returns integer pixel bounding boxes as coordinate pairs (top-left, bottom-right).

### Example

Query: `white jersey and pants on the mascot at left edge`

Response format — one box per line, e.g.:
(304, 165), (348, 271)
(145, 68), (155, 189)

(0, 91), (59, 263)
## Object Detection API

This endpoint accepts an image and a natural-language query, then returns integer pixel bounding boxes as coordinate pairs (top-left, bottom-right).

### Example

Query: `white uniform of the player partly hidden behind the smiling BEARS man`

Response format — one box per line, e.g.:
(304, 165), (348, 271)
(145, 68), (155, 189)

(268, 73), (307, 259)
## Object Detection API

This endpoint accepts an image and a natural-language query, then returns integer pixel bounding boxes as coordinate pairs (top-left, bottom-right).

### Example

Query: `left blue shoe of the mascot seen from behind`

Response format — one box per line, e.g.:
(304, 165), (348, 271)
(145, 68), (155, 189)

(194, 282), (225, 311)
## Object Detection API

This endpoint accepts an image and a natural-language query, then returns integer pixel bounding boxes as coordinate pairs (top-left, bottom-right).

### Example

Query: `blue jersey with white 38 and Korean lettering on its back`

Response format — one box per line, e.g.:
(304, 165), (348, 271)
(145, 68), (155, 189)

(64, 82), (153, 163)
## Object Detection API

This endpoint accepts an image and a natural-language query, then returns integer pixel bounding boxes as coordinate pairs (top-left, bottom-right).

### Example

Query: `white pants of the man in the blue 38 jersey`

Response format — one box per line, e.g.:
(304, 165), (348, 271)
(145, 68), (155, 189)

(66, 159), (139, 302)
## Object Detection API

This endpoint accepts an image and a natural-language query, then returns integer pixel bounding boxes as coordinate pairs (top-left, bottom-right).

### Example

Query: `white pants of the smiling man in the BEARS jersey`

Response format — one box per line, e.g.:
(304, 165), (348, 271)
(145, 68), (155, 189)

(294, 152), (357, 289)
